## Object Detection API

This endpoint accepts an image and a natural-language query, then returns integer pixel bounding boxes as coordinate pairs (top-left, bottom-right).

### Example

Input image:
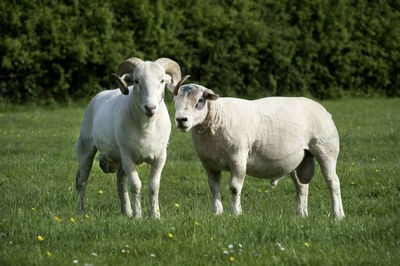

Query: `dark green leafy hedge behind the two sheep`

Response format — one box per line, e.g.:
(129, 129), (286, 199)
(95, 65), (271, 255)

(0, 0), (400, 102)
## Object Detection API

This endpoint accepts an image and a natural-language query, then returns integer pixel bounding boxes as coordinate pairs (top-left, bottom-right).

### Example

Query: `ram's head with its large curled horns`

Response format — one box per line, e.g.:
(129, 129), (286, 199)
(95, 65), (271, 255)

(111, 57), (181, 116)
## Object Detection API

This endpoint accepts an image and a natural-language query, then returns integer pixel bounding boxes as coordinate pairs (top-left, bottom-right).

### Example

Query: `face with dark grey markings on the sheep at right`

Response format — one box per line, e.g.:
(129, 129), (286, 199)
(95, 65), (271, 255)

(174, 84), (218, 132)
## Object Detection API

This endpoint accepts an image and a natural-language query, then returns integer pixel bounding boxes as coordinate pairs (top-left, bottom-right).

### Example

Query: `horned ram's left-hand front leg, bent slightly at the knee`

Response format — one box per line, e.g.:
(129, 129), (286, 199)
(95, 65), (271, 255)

(122, 161), (142, 218)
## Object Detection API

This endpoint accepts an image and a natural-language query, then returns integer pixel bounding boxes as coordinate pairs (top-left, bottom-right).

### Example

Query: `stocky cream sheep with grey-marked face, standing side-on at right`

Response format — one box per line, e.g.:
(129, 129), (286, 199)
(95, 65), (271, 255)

(170, 77), (344, 219)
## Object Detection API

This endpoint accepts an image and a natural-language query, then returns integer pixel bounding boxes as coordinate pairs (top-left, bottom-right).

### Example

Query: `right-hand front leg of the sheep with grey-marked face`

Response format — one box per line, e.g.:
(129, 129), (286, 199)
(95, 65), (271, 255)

(230, 157), (246, 215)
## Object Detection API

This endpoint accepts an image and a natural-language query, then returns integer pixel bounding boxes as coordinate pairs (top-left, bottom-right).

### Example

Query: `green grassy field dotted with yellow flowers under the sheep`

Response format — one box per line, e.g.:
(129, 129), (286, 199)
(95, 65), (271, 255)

(0, 99), (400, 265)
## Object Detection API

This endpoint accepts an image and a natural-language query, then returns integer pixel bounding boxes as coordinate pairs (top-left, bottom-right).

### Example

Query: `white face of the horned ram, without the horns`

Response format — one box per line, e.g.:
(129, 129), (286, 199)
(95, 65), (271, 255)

(132, 62), (171, 117)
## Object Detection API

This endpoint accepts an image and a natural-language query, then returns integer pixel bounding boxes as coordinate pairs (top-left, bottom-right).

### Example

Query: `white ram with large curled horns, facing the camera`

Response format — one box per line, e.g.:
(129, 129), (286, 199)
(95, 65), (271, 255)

(76, 57), (181, 218)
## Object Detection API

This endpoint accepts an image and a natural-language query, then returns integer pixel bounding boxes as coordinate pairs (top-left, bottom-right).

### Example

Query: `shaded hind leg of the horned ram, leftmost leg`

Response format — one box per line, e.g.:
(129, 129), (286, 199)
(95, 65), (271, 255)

(76, 141), (97, 213)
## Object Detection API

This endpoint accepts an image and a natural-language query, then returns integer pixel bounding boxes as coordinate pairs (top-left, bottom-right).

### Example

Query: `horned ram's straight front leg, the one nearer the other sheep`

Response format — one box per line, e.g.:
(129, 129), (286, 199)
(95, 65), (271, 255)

(149, 150), (167, 219)
